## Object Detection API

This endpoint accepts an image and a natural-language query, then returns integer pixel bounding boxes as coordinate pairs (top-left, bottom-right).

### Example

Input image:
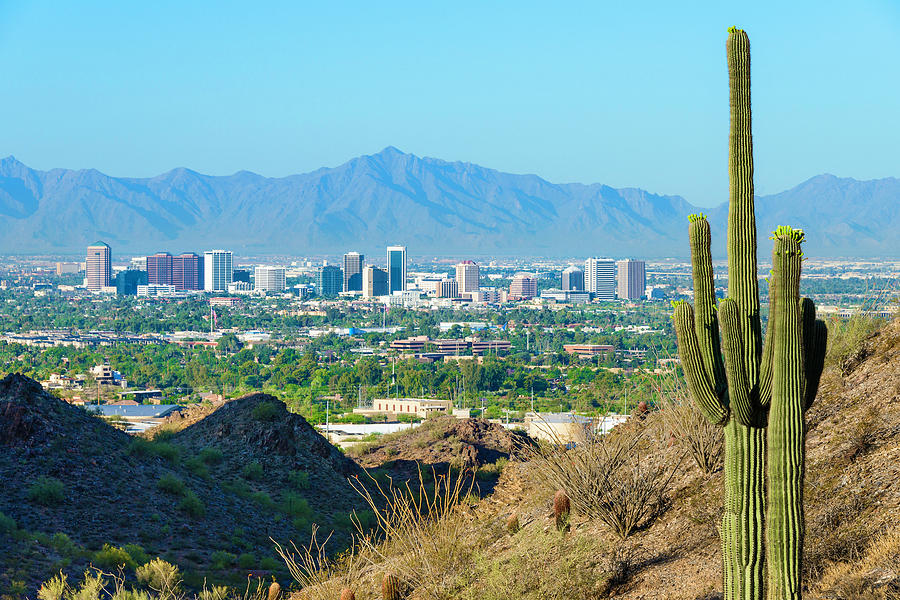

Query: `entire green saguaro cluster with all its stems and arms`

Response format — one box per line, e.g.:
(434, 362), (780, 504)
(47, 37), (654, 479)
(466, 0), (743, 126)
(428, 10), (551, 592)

(675, 28), (826, 600)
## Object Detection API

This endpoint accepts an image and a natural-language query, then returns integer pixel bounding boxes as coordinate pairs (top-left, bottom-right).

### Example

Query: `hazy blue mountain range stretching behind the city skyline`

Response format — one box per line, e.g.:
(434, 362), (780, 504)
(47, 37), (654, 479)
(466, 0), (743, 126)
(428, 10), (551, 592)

(0, 147), (900, 257)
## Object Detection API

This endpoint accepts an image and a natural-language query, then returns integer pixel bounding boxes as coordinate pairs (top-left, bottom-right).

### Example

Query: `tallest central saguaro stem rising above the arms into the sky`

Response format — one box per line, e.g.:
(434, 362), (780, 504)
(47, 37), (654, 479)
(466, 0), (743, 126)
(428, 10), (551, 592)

(726, 28), (762, 388)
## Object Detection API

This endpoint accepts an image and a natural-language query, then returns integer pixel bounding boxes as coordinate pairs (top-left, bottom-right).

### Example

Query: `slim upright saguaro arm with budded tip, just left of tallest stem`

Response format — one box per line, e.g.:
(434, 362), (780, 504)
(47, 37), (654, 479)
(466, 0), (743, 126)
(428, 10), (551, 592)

(688, 214), (726, 399)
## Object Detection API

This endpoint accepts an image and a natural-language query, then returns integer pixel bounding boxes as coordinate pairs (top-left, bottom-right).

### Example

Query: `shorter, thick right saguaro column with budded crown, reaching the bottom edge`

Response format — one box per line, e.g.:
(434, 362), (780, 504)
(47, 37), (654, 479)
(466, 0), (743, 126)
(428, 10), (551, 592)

(766, 227), (810, 600)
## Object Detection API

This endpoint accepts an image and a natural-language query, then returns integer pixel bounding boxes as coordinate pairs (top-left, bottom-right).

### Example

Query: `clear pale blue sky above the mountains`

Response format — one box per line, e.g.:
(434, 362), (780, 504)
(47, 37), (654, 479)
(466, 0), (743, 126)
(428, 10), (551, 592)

(0, 0), (900, 205)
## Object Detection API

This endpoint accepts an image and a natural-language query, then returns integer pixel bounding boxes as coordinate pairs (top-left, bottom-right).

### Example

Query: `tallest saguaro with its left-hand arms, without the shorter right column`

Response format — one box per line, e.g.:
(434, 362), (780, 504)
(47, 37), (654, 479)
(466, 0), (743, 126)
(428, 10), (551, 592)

(675, 28), (769, 600)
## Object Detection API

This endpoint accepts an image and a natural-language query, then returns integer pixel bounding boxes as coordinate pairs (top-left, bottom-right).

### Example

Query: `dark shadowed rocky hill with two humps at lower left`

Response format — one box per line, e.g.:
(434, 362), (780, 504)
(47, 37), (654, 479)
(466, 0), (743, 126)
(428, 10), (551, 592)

(0, 382), (362, 597)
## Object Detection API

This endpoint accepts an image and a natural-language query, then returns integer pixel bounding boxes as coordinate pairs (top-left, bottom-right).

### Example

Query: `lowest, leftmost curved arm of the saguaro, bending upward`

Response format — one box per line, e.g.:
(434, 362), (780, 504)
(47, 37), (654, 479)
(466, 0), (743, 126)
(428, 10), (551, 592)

(675, 302), (728, 424)
